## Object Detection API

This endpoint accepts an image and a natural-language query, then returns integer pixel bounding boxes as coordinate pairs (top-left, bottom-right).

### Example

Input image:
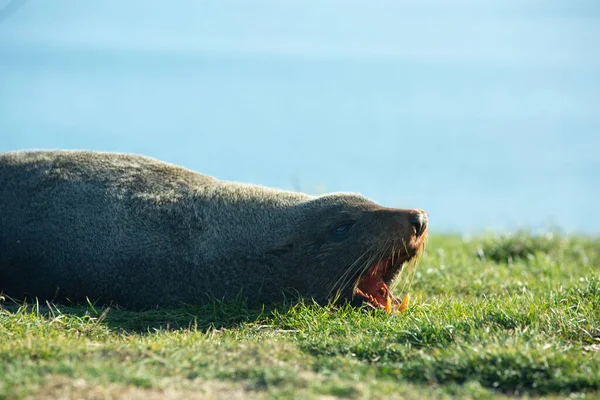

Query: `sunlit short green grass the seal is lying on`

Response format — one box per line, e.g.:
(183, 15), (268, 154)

(0, 234), (600, 399)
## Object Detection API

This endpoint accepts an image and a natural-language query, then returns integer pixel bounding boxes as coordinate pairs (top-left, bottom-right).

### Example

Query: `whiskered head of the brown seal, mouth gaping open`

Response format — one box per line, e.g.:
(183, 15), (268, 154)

(268, 194), (428, 312)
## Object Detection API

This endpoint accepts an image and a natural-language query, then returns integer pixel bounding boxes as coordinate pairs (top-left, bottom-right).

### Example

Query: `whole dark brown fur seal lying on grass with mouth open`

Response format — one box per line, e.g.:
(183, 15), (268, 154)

(0, 151), (428, 310)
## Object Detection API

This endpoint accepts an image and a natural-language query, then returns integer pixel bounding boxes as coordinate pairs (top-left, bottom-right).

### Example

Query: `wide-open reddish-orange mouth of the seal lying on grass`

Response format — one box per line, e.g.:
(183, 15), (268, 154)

(354, 256), (410, 314)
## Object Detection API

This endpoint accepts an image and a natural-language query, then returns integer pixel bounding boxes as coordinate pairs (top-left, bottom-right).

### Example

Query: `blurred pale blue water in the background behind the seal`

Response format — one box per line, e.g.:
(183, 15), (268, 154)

(0, 0), (600, 233)
